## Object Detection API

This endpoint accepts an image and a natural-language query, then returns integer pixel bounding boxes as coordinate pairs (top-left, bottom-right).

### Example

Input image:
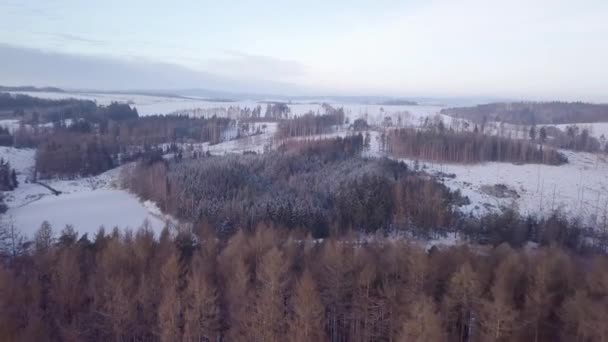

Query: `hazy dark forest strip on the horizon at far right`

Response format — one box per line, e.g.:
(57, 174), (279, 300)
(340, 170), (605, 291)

(441, 102), (608, 125)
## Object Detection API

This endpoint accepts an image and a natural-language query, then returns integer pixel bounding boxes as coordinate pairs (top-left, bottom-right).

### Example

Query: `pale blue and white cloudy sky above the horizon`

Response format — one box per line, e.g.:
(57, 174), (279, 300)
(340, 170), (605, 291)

(0, 0), (608, 101)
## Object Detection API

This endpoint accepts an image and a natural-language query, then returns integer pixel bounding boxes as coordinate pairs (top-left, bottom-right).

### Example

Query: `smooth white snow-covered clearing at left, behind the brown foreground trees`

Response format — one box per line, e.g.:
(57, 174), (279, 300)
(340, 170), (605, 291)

(0, 147), (170, 237)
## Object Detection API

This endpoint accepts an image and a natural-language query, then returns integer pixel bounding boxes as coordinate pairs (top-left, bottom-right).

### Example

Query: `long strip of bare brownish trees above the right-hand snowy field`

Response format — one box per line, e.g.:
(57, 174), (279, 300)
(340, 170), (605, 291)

(386, 127), (567, 165)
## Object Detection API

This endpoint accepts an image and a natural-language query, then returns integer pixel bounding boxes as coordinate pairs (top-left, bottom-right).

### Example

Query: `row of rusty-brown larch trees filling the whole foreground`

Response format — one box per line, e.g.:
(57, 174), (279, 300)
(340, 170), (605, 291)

(0, 224), (608, 342)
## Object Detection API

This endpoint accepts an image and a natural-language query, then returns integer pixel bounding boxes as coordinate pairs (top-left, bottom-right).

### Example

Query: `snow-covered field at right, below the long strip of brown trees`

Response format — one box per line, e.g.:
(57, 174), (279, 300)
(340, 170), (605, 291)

(404, 151), (608, 225)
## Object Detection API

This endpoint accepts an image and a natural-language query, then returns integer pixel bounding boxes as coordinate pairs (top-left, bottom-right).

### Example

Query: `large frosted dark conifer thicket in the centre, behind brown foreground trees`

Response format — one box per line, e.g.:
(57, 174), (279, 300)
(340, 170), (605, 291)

(124, 135), (459, 236)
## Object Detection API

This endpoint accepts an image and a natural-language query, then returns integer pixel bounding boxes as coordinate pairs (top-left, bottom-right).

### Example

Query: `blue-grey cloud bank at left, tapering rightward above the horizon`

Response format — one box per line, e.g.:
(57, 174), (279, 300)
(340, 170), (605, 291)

(0, 43), (304, 94)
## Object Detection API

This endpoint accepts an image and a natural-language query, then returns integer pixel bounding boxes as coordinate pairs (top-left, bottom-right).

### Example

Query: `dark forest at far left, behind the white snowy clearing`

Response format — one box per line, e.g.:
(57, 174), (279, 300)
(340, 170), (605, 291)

(0, 93), (235, 178)
